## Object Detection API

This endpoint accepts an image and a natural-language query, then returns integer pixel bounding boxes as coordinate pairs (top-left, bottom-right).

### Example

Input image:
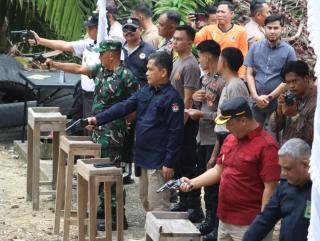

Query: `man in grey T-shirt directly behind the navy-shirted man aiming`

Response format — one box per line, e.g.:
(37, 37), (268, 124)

(170, 25), (204, 223)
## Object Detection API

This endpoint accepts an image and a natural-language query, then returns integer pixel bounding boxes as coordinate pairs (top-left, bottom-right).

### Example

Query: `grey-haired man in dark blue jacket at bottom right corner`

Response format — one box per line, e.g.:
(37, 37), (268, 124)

(242, 138), (312, 241)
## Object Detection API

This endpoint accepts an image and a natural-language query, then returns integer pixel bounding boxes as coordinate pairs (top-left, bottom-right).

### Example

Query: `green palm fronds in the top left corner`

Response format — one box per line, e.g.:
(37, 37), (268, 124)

(0, 0), (96, 52)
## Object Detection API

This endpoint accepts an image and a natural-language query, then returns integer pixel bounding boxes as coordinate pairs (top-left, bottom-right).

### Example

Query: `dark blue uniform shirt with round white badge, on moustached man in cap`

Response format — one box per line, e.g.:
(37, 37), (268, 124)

(122, 40), (155, 86)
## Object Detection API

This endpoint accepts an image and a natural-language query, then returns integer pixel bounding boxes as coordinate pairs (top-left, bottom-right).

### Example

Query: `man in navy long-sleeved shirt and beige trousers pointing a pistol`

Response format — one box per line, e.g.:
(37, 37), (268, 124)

(88, 52), (184, 211)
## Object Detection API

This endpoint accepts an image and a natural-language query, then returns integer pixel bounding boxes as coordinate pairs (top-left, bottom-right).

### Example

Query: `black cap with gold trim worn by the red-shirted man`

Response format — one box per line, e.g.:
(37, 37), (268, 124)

(215, 96), (252, 125)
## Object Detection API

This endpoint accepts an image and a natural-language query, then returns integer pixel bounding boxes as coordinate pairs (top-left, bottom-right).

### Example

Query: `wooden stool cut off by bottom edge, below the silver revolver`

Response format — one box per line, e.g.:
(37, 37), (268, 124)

(146, 211), (201, 241)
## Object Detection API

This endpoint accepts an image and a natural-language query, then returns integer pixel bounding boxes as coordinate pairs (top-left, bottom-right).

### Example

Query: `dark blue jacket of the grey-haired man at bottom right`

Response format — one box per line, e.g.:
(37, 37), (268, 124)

(242, 179), (312, 241)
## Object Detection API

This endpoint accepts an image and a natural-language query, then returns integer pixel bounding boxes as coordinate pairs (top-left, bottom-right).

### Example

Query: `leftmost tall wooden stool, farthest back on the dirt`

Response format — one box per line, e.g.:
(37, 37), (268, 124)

(27, 107), (67, 210)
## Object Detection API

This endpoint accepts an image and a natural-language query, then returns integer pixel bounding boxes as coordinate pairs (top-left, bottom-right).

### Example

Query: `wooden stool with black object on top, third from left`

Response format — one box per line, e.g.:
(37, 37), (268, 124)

(78, 158), (123, 241)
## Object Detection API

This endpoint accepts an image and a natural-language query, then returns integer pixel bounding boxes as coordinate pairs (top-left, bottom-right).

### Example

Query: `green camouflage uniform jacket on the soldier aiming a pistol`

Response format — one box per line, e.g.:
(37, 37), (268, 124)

(90, 64), (138, 160)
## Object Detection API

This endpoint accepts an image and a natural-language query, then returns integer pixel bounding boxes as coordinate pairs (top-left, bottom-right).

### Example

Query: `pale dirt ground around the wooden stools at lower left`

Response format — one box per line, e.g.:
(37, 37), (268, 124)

(0, 143), (145, 241)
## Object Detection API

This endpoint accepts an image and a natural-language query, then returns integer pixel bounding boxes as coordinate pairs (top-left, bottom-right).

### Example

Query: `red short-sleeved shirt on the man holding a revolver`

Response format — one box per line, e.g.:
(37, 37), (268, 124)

(217, 126), (280, 225)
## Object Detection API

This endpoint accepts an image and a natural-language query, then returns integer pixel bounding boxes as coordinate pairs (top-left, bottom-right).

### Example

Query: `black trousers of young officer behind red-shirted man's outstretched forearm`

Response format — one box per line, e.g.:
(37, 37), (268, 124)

(197, 145), (219, 213)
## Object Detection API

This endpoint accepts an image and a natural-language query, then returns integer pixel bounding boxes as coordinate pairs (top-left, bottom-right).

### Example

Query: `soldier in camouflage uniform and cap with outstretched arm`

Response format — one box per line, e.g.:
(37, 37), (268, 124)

(46, 40), (138, 229)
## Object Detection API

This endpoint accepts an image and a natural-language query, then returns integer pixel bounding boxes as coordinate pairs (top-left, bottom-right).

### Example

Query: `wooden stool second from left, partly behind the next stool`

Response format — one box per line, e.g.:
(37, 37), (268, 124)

(54, 136), (101, 240)
